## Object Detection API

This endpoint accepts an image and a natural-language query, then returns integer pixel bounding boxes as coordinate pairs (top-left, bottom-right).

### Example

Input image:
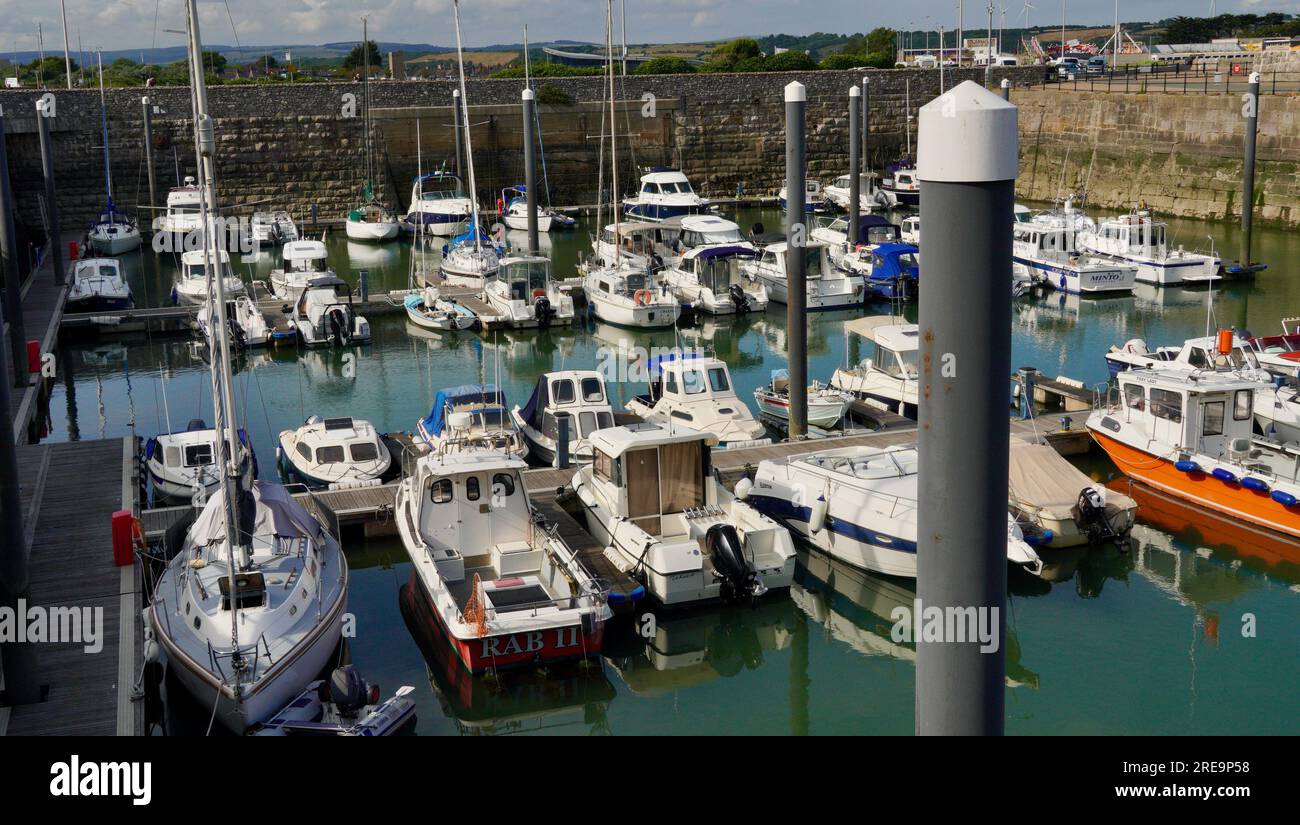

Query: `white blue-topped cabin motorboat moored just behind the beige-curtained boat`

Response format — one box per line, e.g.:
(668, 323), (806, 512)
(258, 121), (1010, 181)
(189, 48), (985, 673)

(628, 352), (771, 447)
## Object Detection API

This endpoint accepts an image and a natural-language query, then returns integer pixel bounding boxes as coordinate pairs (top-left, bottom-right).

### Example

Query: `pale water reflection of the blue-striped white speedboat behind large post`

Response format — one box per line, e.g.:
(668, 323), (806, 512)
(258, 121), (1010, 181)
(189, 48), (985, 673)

(790, 547), (1039, 690)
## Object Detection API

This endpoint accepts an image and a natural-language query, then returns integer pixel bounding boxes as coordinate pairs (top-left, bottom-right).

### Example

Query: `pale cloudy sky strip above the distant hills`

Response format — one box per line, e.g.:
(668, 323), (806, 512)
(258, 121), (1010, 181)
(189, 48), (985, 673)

(10, 0), (1297, 52)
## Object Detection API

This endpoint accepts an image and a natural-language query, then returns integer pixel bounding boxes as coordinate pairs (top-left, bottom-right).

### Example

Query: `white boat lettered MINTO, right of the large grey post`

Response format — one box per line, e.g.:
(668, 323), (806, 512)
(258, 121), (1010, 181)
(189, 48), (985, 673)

(1011, 218), (1138, 295)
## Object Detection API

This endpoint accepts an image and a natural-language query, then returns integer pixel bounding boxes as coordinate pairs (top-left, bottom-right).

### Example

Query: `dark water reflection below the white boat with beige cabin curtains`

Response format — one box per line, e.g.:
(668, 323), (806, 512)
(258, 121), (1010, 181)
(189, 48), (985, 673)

(603, 598), (802, 698)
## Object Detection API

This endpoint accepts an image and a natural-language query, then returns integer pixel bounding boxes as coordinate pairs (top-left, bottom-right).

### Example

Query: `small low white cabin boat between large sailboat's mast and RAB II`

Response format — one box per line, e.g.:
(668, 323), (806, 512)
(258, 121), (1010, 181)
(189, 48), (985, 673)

(276, 416), (400, 490)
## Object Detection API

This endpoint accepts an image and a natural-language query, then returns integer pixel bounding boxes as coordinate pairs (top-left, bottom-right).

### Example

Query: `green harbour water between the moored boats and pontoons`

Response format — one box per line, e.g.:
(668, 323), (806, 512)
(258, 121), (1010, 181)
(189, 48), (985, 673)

(49, 210), (1300, 734)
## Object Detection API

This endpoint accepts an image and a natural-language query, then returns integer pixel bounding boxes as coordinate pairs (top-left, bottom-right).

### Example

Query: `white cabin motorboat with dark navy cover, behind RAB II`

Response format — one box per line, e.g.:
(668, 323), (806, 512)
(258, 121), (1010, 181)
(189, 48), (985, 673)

(510, 369), (614, 464)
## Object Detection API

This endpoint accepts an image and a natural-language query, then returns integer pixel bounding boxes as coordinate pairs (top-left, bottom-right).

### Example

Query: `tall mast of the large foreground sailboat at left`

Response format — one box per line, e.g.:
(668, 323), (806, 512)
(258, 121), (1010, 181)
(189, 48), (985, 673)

(185, 0), (241, 670)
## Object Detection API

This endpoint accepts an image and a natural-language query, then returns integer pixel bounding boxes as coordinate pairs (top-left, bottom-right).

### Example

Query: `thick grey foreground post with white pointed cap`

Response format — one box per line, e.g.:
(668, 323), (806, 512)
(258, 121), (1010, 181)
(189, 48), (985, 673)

(913, 81), (1018, 734)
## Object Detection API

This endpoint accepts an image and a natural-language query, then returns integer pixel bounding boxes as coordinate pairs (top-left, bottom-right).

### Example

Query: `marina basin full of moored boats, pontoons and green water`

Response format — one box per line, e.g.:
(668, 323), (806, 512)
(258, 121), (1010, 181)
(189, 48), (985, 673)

(0, 0), (1300, 737)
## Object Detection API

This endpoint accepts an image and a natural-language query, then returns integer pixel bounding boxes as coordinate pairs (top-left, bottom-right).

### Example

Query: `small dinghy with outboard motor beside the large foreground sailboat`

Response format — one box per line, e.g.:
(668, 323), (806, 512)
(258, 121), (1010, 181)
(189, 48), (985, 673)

(252, 665), (415, 737)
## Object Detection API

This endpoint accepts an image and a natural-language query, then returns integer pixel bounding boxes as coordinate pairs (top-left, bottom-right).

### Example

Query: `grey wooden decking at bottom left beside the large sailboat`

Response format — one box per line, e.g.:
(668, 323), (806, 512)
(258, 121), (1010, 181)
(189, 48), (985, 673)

(8, 438), (139, 735)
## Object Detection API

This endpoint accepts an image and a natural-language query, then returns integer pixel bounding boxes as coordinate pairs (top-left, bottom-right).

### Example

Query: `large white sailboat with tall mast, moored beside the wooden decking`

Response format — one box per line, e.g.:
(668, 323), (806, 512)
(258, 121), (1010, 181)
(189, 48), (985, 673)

(146, 0), (348, 733)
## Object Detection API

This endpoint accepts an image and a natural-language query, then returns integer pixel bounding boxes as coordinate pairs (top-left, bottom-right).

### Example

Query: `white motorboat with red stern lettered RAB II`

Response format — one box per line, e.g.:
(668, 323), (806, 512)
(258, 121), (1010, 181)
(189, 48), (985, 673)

(394, 441), (612, 673)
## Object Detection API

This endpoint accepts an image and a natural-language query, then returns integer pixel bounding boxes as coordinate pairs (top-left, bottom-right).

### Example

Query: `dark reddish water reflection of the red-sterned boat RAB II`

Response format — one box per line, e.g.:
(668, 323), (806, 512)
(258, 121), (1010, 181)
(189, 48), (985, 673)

(398, 583), (615, 737)
